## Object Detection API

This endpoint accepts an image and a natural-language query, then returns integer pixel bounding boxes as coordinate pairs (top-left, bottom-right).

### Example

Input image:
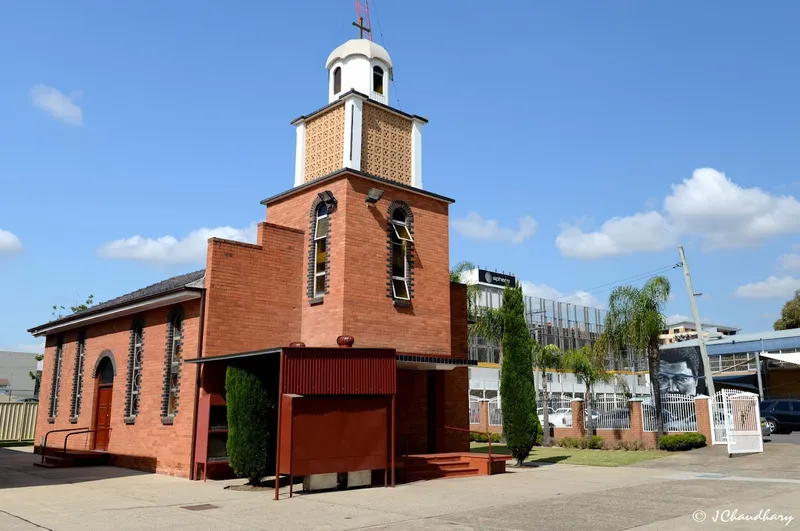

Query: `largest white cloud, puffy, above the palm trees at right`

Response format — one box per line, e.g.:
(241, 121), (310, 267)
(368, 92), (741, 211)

(556, 168), (800, 259)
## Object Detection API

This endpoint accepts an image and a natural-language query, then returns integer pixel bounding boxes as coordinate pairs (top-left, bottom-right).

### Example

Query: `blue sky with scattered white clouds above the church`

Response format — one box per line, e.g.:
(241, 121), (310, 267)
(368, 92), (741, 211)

(0, 0), (800, 349)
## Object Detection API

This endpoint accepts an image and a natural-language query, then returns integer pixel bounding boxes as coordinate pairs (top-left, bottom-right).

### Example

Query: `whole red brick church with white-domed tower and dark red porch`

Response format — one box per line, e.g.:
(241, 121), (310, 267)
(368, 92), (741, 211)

(30, 39), (500, 486)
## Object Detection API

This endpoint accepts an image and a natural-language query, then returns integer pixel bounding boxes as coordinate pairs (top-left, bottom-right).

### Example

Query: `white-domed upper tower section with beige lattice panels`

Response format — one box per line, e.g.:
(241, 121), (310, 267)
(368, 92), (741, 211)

(292, 35), (428, 189)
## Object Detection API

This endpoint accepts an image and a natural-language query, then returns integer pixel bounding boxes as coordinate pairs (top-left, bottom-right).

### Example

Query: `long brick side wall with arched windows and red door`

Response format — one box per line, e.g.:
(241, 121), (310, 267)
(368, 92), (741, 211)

(35, 300), (200, 477)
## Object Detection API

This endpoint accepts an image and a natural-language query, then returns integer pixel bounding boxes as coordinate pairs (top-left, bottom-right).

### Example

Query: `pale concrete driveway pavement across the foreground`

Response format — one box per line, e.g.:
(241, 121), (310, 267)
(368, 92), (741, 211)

(0, 444), (800, 531)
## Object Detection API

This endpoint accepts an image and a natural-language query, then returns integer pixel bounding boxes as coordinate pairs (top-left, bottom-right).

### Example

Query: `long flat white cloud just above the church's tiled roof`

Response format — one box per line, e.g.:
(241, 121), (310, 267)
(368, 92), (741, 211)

(97, 223), (257, 265)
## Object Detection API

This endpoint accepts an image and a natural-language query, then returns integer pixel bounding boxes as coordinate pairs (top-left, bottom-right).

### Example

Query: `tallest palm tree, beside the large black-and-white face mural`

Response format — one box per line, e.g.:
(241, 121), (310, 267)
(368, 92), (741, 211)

(605, 276), (671, 439)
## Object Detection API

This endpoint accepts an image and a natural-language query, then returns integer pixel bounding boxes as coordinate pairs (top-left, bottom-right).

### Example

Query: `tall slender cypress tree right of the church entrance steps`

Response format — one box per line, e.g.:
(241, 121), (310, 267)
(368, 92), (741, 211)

(500, 286), (542, 466)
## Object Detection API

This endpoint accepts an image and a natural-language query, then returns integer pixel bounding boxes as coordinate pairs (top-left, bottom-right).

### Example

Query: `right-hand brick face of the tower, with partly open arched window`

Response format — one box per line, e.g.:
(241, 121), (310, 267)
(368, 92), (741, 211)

(340, 176), (454, 358)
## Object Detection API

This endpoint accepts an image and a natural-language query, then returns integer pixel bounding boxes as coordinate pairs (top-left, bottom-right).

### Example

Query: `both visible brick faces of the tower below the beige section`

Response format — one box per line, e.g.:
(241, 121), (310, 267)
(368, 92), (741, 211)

(267, 175), (454, 355)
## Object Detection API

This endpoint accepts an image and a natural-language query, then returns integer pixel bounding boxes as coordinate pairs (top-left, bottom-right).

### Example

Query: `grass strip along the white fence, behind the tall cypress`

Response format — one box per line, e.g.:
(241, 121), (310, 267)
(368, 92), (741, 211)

(471, 443), (669, 466)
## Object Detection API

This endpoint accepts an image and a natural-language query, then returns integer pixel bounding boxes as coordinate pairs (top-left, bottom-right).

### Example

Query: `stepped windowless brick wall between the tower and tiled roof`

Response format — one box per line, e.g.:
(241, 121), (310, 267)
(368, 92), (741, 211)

(203, 223), (305, 356)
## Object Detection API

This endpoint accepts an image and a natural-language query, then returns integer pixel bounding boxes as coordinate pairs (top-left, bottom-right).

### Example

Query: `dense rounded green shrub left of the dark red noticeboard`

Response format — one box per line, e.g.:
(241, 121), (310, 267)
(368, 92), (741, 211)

(225, 366), (274, 485)
